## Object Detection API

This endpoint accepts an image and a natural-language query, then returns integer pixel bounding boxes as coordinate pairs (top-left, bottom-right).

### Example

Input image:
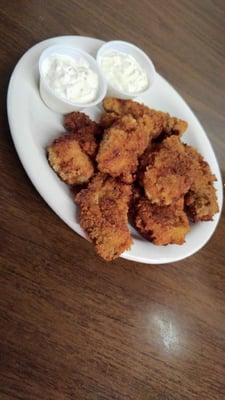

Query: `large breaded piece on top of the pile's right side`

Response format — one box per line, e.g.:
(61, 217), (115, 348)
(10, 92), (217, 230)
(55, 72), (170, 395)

(142, 136), (194, 205)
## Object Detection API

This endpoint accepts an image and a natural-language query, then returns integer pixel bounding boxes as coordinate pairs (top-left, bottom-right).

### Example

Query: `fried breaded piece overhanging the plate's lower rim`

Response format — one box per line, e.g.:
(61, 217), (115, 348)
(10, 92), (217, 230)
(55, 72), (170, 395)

(75, 173), (132, 261)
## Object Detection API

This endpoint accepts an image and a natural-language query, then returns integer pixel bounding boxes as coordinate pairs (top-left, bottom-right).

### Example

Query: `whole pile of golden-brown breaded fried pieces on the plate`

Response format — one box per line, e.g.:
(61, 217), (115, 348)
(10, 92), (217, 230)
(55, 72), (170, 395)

(47, 97), (218, 261)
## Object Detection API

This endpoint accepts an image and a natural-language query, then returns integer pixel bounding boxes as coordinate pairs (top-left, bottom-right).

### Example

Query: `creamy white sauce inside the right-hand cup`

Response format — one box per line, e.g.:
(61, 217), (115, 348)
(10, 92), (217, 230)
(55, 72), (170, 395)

(100, 50), (148, 93)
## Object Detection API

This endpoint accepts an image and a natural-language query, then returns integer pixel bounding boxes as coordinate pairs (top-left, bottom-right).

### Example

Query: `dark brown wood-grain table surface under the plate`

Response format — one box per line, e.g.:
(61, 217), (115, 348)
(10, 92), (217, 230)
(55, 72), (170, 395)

(0, 0), (225, 400)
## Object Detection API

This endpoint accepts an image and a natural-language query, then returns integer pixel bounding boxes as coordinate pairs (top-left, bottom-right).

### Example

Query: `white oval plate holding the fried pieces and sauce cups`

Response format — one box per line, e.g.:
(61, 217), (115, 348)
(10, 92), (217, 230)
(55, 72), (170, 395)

(7, 36), (223, 264)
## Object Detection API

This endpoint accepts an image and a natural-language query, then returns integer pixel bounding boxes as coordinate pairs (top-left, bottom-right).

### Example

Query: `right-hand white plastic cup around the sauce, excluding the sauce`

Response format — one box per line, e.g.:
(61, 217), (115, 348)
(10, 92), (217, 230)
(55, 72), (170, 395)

(96, 40), (156, 99)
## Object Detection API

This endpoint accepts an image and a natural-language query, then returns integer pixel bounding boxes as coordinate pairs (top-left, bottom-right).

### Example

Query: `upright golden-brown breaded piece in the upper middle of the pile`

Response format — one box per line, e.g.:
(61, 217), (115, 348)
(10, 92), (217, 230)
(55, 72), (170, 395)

(96, 111), (154, 183)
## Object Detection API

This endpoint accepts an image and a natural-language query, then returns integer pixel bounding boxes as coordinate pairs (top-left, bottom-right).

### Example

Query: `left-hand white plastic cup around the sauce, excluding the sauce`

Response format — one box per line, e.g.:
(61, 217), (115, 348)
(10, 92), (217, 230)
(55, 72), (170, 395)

(39, 45), (107, 114)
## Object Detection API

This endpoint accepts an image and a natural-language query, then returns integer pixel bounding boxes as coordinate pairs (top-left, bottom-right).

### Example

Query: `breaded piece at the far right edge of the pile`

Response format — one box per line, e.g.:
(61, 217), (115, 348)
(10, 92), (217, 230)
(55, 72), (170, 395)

(185, 145), (219, 222)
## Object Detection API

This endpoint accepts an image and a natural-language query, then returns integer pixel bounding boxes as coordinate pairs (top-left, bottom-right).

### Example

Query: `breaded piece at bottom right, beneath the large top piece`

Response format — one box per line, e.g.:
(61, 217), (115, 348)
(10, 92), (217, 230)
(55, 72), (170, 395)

(135, 197), (190, 245)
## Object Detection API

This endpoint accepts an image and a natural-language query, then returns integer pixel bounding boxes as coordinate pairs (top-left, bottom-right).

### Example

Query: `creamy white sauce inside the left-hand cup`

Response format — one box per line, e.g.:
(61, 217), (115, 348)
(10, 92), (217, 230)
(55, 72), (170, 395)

(42, 54), (99, 104)
